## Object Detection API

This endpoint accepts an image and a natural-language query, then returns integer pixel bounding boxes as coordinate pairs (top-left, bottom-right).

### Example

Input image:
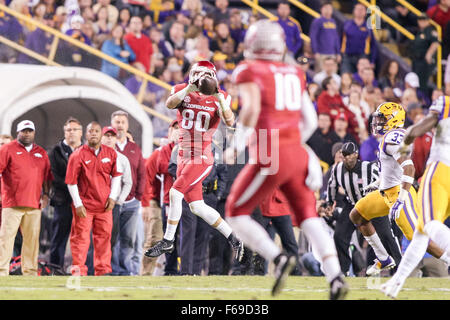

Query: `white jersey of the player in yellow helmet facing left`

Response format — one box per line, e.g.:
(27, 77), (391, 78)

(378, 129), (405, 190)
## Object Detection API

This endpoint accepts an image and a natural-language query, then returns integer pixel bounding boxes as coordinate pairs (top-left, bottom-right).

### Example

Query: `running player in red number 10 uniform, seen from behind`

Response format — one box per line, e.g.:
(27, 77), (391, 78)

(226, 20), (348, 299)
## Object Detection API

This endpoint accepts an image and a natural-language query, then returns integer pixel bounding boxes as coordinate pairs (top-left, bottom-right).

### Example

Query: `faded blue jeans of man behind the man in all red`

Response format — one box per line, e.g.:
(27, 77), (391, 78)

(112, 199), (141, 275)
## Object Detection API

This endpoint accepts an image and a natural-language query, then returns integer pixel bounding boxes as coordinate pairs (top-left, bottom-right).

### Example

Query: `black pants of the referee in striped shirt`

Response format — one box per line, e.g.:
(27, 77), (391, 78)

(333, 201), (401, 274)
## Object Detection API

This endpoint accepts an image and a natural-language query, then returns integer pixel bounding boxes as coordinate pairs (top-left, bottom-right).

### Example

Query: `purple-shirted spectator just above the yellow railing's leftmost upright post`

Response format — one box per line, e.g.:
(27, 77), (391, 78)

(17, 15), (54, 64)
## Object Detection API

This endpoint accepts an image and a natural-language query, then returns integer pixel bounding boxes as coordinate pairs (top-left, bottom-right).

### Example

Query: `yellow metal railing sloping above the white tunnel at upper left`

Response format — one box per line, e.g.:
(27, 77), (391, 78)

(0, 4), (173, 123)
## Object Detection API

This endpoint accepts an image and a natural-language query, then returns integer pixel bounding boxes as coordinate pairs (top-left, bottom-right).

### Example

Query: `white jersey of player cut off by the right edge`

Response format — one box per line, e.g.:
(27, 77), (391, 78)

(428, 96), (450, 166)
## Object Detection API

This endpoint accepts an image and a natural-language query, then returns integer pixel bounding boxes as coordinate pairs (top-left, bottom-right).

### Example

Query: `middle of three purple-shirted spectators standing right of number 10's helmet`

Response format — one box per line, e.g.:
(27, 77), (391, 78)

(309, 1), (341, 71)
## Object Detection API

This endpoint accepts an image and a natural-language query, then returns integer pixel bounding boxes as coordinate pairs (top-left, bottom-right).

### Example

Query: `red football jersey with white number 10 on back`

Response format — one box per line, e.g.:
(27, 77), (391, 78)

(233, 60), (306, 145)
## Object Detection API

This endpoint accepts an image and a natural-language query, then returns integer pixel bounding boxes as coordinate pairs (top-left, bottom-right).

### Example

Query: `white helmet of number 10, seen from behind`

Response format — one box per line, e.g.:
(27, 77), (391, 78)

(244, 19), (286, 61)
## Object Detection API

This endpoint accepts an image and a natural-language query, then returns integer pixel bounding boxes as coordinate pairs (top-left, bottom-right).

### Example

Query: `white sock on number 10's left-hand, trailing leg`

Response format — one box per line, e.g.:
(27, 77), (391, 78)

(227, 215), (281, 261)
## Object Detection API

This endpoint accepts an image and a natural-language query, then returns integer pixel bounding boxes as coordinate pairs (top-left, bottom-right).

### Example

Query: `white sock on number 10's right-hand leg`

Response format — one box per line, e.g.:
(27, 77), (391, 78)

(300, 218), (342, 282)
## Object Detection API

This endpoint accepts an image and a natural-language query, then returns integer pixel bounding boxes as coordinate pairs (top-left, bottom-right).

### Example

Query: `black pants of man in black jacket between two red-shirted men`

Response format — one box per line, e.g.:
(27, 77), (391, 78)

(50, 205), (73, 267)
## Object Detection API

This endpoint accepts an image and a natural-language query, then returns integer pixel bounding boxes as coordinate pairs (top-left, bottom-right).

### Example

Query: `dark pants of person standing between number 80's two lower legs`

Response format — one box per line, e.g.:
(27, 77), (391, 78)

(180, 193), (217, 275)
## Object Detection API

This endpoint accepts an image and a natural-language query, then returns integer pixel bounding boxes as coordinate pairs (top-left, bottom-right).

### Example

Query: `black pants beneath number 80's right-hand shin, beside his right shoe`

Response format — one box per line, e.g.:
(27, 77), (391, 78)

(208, 198), (233, 275)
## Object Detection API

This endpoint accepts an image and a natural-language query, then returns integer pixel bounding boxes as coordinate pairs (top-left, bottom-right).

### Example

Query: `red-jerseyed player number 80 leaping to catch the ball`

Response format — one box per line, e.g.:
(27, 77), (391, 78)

(145, 61), (243, 260)
